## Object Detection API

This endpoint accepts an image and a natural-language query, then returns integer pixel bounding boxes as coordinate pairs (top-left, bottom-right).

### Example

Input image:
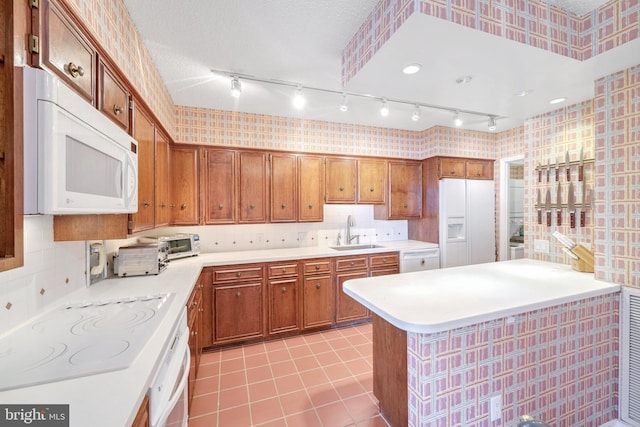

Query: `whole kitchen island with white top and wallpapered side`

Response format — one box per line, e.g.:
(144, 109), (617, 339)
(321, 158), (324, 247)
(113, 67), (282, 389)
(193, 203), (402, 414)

(344, 259), (620, 426)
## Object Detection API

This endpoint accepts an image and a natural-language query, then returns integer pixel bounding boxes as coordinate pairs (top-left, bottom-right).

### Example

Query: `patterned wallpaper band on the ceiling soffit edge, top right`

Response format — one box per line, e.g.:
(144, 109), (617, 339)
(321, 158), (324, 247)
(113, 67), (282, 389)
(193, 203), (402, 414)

(342, 0), (640, 85)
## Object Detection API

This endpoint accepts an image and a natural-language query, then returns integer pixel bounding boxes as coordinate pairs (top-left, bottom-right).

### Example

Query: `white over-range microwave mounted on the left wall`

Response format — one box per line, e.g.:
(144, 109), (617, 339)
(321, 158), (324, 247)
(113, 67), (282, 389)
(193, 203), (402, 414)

(22, 67), (138, 215)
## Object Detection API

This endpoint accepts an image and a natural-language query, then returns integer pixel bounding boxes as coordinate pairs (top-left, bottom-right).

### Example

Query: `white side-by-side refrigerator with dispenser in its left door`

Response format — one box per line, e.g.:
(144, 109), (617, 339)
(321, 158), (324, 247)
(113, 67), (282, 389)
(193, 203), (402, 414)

(438, 179), (496, 268)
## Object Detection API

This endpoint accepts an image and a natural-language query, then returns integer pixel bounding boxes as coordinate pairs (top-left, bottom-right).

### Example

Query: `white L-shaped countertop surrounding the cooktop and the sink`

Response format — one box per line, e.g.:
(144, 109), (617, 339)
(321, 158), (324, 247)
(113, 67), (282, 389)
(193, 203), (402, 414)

(0, 240), (437, 427)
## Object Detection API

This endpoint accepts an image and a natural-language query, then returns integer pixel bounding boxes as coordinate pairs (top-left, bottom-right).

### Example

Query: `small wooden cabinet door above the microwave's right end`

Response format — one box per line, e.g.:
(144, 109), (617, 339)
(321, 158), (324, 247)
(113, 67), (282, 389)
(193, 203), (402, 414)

(98, 61), (129, 131)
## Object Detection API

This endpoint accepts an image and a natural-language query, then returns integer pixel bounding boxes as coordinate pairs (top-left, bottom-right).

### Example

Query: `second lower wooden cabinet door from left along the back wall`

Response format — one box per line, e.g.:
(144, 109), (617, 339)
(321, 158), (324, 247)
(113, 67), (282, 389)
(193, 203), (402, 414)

(268, 277), (299, 335)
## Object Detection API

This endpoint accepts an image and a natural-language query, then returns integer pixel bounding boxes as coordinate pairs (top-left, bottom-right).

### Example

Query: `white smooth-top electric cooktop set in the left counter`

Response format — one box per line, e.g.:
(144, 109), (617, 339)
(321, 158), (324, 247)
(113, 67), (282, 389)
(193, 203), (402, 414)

(0, 293), (174, 391)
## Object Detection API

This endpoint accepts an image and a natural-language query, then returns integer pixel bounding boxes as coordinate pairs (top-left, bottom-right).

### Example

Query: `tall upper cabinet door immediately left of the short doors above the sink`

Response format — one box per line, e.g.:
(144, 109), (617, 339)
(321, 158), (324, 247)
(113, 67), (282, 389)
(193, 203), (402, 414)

(298, 156), (324, 222)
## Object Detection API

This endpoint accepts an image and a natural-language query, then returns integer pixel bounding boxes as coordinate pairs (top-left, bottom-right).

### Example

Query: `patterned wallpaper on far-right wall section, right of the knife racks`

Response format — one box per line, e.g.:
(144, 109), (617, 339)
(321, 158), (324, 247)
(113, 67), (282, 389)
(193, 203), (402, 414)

(595, 65), (640, 288)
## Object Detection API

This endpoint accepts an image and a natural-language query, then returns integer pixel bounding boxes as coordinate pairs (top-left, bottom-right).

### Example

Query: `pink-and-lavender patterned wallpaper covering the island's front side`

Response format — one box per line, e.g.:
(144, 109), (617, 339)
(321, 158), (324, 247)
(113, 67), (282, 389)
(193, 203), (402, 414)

(407, 294), (620, 427)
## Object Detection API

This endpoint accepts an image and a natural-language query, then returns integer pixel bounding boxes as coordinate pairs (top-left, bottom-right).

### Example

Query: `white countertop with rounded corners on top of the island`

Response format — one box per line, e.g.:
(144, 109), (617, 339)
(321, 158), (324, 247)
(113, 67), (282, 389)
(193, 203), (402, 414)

(343, 259), (621, 333)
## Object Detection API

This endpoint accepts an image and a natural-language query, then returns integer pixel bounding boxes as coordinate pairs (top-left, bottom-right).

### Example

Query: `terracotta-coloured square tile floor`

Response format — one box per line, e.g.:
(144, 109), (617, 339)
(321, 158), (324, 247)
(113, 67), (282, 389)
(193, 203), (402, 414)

(189, 323), (387, 427)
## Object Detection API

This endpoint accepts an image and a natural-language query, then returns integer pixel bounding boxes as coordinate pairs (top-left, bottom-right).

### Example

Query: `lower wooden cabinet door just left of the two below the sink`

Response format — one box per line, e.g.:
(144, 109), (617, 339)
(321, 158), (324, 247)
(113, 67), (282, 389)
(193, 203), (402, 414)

(302, 275), (334, 329)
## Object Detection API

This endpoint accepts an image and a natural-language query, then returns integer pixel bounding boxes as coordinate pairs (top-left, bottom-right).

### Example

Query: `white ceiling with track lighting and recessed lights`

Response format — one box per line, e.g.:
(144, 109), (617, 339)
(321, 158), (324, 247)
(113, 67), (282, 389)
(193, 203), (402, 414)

(124, 0), (640, 131)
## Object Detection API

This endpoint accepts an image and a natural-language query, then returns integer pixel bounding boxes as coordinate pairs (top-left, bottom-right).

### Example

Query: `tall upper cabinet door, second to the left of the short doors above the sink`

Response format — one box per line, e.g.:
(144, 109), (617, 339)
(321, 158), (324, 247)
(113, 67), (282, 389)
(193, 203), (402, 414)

(270, 154), (297, 222)
